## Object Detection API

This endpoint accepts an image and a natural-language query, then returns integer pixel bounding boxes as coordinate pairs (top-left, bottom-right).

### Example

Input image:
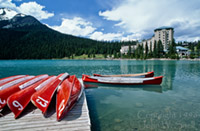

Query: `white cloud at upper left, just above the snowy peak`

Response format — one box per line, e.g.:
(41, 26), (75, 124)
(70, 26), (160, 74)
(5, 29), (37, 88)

(0, 0), (54, 20)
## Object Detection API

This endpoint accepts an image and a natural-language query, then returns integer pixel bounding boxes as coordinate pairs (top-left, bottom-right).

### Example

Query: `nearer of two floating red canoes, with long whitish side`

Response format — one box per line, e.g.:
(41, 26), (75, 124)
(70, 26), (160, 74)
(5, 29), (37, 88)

(82, 75), (163, 85)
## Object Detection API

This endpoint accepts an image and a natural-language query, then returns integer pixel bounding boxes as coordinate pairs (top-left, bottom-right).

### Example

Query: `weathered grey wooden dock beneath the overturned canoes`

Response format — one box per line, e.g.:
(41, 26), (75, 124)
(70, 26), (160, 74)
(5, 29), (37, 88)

(0, 92), (91, 131)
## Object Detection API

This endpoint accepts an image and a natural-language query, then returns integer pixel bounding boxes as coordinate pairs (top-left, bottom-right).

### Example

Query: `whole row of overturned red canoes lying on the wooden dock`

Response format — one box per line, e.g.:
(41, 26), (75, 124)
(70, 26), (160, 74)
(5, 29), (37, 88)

(0, 73), (83, 121)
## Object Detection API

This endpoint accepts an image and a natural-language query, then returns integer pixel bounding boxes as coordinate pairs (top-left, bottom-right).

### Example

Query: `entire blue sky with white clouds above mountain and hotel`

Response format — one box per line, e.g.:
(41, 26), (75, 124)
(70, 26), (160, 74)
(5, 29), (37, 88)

(0, 0), (200, 41)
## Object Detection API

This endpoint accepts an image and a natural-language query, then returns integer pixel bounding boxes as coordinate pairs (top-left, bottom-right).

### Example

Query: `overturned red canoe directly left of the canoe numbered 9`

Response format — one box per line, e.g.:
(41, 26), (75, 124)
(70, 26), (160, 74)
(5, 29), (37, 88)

(0, 75), (48, 109)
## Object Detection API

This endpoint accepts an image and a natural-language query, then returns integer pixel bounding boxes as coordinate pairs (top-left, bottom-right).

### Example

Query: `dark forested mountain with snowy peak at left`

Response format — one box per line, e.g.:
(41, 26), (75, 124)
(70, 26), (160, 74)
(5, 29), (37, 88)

(0, 8), (133, 59)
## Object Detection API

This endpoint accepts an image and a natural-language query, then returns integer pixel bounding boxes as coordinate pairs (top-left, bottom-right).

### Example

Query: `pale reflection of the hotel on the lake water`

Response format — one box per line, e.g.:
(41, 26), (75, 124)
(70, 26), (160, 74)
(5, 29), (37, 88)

(120, 60), (177, 91)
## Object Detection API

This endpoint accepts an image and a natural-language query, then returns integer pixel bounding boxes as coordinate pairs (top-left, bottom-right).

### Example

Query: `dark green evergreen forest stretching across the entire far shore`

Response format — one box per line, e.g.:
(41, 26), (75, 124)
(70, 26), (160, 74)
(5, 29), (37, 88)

(0, 25), (200, 59)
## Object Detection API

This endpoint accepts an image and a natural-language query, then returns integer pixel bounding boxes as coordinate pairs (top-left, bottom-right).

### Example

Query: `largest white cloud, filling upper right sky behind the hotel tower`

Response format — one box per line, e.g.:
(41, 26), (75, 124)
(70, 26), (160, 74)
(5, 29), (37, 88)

(99, 0), (200, 40)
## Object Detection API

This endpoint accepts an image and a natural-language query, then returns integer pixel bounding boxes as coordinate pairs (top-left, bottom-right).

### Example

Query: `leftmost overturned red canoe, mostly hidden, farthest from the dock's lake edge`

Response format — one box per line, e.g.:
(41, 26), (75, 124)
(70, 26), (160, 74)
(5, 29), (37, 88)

(0, 75), (27, 87)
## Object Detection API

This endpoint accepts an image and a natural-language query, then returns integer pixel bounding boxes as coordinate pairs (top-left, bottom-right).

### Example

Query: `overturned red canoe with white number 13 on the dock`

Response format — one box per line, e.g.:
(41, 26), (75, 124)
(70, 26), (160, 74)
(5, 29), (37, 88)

(31, 73), (69, 114)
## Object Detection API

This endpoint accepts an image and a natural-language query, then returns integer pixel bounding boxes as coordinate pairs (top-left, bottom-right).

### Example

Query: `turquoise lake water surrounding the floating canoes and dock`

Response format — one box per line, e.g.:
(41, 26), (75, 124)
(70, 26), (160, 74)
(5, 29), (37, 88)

(0, 60), (200, 131)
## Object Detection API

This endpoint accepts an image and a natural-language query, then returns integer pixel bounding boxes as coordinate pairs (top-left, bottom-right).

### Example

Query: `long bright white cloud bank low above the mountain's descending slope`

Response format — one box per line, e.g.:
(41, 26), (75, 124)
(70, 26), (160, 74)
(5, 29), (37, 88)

(47, 17), (138, 41)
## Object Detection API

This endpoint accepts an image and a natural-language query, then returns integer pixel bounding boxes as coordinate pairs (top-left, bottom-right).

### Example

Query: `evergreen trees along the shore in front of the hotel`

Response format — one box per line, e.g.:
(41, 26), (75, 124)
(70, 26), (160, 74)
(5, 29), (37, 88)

(121, 40), (200, 59)
